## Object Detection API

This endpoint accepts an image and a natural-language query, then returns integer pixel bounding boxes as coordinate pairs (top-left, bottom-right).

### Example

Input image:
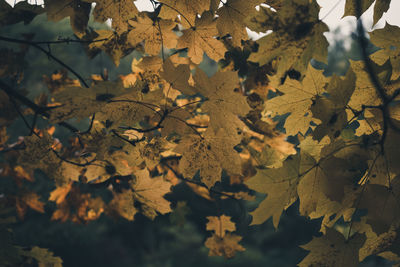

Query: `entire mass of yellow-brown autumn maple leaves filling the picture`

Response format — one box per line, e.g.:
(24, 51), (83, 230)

(0, 0), (400, 266)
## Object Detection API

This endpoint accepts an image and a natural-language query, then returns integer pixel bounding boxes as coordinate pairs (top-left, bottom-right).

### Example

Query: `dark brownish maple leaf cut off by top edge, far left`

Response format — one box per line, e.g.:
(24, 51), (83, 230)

(44, 0), (91, 37)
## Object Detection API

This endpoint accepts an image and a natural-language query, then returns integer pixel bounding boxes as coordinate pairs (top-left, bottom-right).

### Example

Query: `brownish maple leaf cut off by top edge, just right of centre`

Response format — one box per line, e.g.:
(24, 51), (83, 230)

(217, 0), (264, 46)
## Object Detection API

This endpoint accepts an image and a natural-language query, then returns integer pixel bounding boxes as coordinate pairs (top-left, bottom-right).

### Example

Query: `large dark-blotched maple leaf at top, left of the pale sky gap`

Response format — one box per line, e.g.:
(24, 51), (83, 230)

(249, 0), (329, 77)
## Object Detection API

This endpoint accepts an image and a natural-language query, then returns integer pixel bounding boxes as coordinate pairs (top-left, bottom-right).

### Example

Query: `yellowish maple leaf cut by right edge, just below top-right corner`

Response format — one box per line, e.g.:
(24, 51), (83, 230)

(370, 23), (400, 80)
